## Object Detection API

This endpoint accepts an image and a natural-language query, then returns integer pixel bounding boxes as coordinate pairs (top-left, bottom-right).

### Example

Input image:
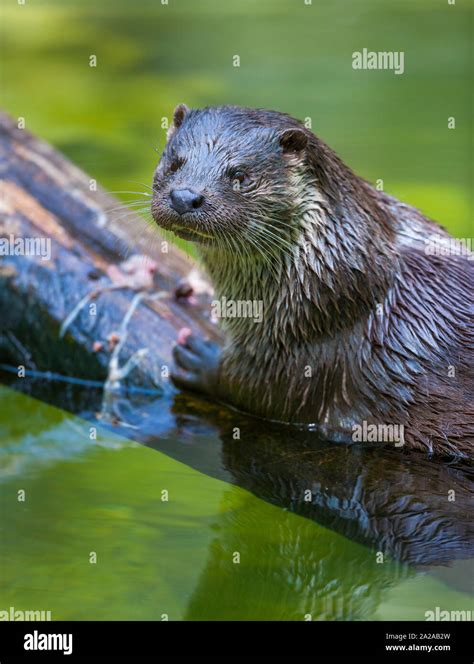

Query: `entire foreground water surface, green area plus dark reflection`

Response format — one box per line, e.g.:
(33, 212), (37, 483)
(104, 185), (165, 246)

(0, 386), (474, 620)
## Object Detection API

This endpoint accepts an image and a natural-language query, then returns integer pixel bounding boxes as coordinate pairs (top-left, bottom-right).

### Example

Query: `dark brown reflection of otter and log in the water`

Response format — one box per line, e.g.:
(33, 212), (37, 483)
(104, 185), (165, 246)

(136, 395), (474, 566)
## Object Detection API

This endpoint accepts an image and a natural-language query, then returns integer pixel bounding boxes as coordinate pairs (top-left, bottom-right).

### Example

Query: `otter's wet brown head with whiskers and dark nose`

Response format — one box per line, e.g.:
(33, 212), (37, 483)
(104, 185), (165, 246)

(152, 104), (311, 257)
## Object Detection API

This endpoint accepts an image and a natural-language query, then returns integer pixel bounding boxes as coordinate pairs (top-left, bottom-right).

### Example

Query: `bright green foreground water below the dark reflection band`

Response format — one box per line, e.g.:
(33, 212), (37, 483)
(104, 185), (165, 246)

(0, 387), (472, 620)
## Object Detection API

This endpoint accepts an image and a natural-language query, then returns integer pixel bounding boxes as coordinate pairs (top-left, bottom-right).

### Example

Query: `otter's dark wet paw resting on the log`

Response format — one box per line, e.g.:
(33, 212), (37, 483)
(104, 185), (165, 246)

(171, 334), (220, 396)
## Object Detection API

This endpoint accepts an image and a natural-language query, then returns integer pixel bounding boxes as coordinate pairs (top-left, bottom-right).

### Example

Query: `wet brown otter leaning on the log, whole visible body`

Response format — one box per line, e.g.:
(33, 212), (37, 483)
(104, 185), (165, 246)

(152, 104), (474, 459)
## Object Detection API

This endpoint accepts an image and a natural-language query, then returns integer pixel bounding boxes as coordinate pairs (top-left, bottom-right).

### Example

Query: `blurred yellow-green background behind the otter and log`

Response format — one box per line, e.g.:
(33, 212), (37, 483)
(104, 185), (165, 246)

(1, 0), (473, 237)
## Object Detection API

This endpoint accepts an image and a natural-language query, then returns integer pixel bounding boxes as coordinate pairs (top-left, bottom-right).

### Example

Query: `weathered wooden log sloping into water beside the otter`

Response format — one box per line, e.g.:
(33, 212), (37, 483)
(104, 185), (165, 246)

(0, 114), (221, 392)
